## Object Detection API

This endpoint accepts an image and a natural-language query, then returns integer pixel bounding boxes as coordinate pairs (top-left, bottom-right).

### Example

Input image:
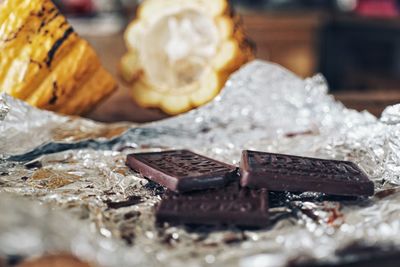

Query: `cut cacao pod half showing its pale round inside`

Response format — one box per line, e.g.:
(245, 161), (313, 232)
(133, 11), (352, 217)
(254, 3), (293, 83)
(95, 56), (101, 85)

(120, 0), (253, 115)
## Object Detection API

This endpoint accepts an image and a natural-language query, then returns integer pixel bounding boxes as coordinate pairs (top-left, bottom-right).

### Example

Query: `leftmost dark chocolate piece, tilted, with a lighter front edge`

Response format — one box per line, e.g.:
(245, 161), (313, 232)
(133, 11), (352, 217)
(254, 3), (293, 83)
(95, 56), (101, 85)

(127, 150), (237, 192)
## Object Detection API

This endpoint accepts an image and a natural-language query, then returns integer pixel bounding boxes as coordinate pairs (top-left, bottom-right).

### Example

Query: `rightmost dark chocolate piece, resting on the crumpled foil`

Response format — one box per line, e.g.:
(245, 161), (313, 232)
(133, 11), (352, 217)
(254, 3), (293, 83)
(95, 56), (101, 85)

(240, 151), (374, 196)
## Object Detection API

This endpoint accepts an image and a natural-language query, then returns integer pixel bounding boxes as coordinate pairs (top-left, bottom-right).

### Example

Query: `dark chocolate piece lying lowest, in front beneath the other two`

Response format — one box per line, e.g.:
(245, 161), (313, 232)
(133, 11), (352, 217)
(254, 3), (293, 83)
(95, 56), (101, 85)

(156, 183), (269, 227)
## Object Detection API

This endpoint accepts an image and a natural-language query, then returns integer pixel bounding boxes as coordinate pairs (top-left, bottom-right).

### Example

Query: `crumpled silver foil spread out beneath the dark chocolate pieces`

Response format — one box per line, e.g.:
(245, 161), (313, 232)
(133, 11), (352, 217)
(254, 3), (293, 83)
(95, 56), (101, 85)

(0, 61), (400, 267)
